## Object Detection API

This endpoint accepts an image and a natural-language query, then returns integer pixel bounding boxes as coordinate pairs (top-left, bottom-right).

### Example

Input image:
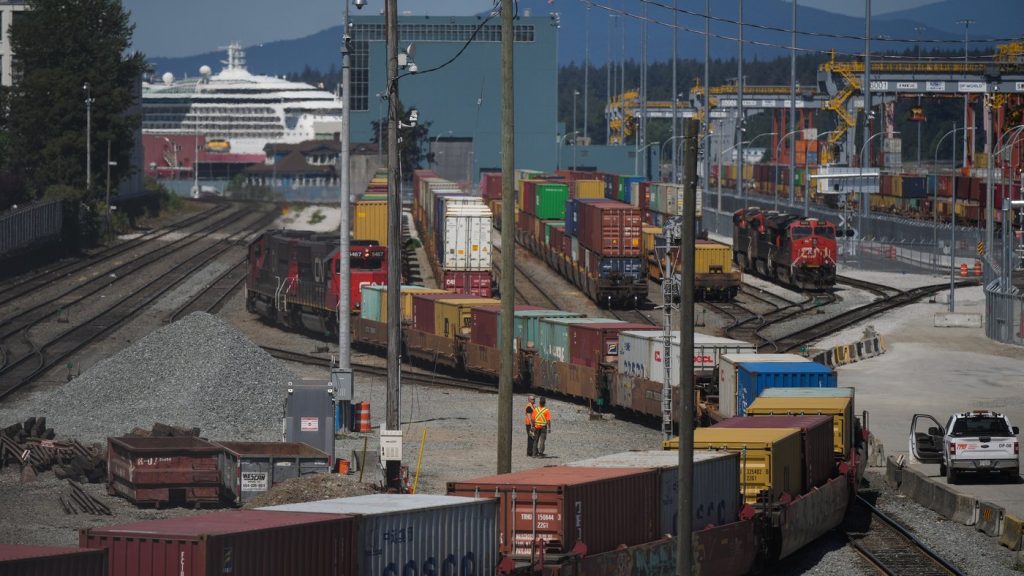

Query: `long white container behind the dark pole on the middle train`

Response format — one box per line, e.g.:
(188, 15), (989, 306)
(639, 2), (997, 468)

(618, 330), (757, 383)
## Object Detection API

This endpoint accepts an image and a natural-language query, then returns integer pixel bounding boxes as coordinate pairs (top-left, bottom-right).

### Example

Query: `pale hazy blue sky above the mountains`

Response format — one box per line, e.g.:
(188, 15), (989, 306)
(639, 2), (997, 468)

(123, 0), (936, 56)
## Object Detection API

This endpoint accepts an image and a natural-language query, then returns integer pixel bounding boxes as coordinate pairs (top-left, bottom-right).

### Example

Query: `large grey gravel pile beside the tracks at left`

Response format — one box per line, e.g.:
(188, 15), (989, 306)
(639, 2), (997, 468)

(0, 313), (296, 442)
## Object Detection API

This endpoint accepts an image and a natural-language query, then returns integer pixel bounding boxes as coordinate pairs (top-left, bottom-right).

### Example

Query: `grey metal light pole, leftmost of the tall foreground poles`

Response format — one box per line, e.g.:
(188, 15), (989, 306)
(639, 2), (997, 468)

(331, 0), (356, 431)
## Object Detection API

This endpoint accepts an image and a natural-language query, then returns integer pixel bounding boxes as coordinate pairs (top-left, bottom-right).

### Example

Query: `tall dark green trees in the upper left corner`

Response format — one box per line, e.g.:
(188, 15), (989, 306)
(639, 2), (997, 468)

(5, 0), (145, 203)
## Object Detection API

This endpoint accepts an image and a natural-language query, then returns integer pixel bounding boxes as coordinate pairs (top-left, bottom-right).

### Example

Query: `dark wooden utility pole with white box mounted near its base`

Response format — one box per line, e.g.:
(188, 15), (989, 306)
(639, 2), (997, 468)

(384, 0), (401, 489)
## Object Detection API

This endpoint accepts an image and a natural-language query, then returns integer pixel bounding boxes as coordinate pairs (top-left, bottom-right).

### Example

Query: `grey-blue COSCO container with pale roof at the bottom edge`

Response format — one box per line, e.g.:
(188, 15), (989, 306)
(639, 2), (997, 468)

(260, 494), (500, 576)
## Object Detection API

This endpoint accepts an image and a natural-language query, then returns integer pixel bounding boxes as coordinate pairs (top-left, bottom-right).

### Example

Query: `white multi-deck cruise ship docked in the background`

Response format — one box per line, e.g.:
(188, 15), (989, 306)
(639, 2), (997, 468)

(142, 43), (342, 154)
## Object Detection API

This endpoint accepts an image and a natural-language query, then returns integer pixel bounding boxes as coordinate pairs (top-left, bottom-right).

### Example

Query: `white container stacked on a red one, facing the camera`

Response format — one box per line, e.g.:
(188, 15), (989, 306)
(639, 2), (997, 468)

(443, 204), (493, 271)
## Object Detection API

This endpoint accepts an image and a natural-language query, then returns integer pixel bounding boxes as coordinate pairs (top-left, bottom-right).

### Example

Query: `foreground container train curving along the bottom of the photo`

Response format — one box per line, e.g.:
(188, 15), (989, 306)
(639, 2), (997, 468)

(19, 388), (864, 576)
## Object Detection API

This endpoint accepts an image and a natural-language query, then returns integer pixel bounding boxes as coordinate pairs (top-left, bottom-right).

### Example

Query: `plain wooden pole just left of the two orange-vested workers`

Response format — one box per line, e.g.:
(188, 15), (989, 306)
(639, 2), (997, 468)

(498, 0), (515, 474)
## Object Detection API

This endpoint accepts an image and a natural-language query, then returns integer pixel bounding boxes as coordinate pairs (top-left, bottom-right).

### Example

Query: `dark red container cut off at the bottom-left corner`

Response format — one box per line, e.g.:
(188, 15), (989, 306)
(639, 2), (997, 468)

(0, 541), (109, 576)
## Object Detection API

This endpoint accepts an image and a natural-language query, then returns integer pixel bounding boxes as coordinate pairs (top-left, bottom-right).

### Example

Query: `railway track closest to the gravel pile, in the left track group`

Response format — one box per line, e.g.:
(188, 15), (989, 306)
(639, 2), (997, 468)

(0, 207), (275, 399)
